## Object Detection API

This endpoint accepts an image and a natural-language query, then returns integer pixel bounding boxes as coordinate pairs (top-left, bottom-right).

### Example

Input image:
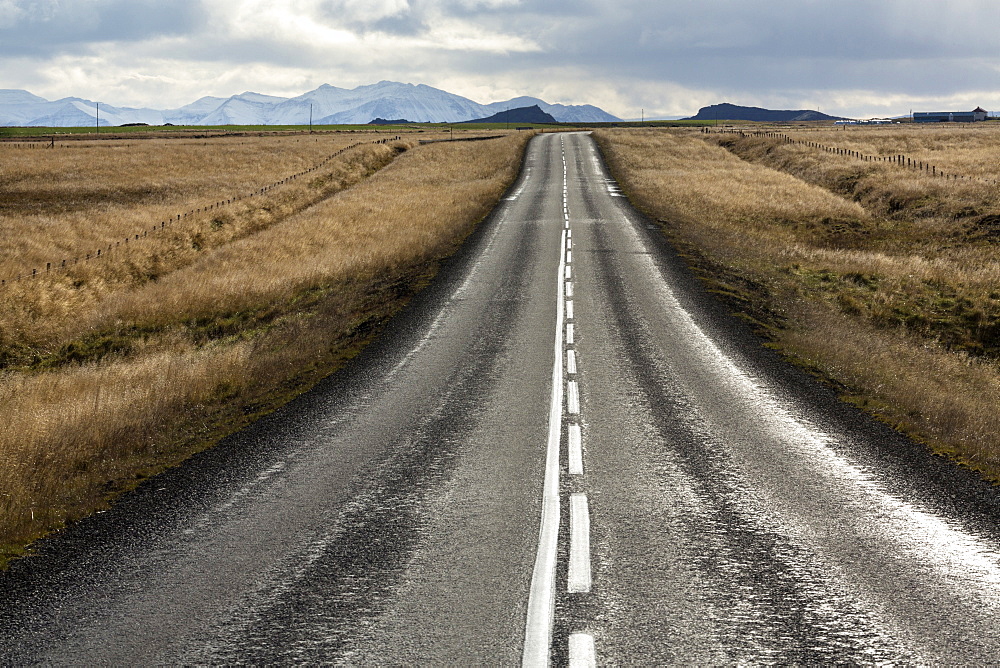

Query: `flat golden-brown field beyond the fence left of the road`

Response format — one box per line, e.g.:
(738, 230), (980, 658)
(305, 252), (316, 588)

(0, 135), (371, 278)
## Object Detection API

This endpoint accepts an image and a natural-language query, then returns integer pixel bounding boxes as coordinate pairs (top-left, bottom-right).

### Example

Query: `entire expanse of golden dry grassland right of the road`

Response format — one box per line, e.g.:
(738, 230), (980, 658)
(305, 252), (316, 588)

(598, 127), (1000, 480)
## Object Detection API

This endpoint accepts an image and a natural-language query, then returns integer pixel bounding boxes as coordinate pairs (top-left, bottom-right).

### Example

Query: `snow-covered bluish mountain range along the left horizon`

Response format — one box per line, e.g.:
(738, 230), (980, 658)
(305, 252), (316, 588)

(0, 81), (621, 127)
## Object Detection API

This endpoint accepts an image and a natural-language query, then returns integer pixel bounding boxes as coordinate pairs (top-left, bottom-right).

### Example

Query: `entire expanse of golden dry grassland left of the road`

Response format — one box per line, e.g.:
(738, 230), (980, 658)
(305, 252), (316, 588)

(0, 126), (529, 562)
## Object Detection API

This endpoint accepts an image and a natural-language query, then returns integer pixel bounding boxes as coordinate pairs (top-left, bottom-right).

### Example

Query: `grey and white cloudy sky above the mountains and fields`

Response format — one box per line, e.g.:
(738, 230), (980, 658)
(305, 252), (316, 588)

(0, 0), (1000, 118)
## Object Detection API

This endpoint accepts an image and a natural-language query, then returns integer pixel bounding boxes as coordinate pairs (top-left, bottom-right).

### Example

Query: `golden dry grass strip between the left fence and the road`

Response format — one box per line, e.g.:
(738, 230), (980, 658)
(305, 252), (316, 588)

(0, 128), (528, 553)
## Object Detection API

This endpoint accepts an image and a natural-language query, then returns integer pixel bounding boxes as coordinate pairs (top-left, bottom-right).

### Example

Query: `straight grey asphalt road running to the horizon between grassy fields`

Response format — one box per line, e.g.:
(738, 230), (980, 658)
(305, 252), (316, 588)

(0, 134), (1000, 665)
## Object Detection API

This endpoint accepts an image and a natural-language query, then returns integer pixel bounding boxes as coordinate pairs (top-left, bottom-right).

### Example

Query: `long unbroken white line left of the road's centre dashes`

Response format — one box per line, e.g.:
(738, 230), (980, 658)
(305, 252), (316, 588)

(521, 226), (566, 666)
